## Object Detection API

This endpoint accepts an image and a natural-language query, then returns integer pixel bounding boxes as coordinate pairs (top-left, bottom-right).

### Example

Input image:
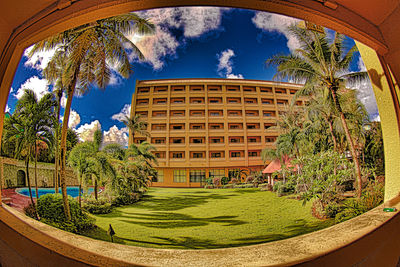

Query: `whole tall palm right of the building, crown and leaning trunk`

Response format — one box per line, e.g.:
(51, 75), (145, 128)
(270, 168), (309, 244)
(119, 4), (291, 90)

(266, 26), (368, 197)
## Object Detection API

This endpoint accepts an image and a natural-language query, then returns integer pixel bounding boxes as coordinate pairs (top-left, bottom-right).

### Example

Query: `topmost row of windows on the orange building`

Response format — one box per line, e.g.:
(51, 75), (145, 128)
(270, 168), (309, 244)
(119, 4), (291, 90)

(137, 85), (297, 94)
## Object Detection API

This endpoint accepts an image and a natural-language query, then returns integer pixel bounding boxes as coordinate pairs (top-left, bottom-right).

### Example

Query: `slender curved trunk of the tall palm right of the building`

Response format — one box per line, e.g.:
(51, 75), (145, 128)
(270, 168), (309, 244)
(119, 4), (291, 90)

(331, 88), (362, 198)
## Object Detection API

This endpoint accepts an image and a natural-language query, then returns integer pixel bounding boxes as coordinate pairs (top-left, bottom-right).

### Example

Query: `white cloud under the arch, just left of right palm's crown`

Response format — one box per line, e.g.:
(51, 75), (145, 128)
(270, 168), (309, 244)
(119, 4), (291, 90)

(252, 11), (300, 52)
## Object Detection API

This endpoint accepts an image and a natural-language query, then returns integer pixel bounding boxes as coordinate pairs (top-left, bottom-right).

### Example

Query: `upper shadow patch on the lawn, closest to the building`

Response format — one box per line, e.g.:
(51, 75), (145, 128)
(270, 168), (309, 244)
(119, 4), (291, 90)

(135, 194), (237, 211)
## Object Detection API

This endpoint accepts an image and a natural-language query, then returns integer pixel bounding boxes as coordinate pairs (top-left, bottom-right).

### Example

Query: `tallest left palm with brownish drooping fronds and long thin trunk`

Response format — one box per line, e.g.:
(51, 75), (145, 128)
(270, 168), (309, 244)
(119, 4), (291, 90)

(30, 13), (155, 219)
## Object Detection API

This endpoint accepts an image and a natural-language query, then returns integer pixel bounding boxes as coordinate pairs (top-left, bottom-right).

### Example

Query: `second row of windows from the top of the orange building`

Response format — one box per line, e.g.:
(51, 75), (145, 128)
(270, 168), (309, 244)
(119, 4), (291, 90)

(136, 97), (302, 106)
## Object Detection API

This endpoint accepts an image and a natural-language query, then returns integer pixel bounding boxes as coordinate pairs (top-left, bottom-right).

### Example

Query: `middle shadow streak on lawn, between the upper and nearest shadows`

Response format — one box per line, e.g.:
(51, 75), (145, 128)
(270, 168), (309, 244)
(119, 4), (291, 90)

(119, 212), (248, 229)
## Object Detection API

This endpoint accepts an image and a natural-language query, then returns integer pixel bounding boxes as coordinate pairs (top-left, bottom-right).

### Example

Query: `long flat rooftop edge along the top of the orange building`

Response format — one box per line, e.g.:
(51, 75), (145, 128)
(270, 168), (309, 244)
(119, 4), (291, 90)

(137, 78), (303, 86)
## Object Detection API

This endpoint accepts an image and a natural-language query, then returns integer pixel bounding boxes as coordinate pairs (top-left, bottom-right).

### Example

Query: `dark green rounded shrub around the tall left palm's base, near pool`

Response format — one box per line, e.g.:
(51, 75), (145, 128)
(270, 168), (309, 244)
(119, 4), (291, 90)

(37, 194), (96, 233)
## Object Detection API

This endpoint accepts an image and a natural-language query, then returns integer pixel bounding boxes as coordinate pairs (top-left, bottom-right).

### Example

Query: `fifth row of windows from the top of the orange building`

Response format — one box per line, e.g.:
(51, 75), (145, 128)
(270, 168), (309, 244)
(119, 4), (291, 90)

(135, 136), (276, 144)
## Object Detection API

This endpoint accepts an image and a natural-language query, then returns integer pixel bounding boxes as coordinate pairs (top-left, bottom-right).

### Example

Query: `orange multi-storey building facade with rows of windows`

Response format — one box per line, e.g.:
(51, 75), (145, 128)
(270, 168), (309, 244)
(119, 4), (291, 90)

(129, 79), (304, 187)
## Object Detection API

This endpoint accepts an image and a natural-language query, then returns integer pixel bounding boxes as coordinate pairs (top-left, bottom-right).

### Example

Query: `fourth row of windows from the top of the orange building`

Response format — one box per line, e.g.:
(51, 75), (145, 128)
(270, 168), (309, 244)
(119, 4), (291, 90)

(151, 122), (276, 131)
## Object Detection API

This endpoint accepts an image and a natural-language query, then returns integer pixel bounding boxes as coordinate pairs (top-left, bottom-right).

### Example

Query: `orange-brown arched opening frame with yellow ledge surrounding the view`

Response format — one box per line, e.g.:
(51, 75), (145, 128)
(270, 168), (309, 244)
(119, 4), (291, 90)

(0, 0), (400, 266)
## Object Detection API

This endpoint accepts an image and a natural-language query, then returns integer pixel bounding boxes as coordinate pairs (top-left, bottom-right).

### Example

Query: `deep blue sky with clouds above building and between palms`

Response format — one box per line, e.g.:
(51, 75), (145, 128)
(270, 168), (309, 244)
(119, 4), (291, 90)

(7, 7), (378, 147)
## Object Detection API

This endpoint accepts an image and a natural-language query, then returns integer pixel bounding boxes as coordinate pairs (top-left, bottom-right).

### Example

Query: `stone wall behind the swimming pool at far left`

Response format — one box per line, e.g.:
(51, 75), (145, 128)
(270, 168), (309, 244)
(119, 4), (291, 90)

(0, 157), (78, 188)
